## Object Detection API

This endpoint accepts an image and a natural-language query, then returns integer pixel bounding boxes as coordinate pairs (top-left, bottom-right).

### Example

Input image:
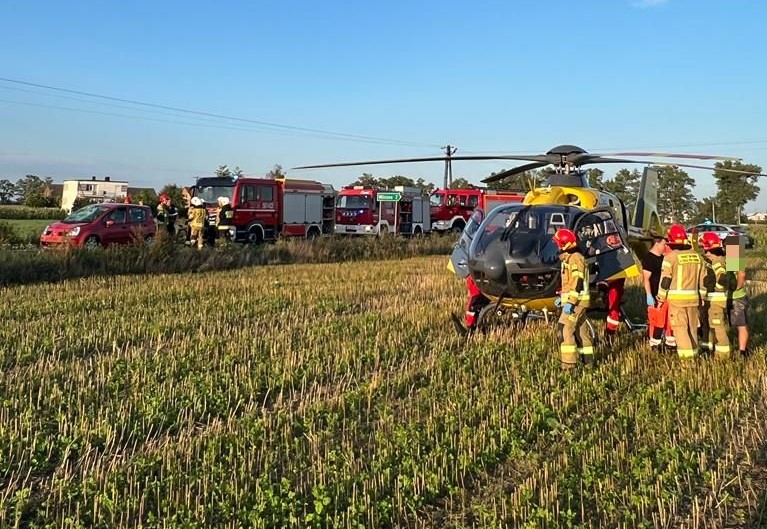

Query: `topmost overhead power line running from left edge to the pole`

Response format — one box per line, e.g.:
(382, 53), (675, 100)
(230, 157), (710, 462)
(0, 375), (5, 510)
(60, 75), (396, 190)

(0, 77), (439, 147)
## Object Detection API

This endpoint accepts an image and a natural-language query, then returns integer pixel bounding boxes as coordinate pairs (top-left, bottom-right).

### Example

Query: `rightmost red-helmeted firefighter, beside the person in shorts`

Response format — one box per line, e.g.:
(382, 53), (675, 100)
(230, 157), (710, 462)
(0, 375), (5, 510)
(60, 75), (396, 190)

(699, 231), (730, 359)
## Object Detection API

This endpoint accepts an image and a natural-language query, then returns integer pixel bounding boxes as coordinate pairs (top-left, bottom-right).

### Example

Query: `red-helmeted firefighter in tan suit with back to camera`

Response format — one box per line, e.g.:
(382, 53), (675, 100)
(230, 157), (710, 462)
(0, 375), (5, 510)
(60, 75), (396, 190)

(658, 224), (706, 360)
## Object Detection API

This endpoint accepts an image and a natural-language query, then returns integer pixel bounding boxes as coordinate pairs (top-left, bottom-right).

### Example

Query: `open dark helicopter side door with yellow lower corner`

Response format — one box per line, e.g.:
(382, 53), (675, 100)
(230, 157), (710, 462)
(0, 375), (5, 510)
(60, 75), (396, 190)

(573, 207), (639, 282)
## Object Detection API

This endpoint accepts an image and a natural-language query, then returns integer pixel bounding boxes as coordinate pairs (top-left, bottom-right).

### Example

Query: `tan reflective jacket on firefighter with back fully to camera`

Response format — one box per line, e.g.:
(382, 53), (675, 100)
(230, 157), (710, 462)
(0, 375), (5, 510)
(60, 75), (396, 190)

(658, 248), (706, 307)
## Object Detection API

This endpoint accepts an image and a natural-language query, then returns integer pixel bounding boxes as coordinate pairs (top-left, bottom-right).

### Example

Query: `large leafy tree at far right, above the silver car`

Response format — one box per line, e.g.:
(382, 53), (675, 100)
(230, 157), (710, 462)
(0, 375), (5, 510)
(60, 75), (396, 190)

(714, 160), (762, 222)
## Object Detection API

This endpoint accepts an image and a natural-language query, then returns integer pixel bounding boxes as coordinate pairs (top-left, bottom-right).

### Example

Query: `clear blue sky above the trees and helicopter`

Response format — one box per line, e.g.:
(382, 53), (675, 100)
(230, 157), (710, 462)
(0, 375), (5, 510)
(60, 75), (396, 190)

(0, 0), (767, 212)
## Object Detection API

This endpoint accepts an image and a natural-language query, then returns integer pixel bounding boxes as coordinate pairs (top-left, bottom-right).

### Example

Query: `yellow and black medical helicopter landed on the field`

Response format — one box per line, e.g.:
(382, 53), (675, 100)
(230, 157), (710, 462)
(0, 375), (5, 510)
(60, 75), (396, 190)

(294, 145), (767, 330)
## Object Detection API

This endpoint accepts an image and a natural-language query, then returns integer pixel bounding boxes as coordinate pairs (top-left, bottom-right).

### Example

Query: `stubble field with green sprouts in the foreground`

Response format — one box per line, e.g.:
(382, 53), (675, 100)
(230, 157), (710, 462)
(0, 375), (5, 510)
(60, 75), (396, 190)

(0, 256), (767, 529)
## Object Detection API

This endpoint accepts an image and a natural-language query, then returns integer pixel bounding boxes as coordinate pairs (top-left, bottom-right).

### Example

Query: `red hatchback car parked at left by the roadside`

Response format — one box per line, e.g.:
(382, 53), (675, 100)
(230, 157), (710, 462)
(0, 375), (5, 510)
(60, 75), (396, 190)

(40, 203), (157, 247)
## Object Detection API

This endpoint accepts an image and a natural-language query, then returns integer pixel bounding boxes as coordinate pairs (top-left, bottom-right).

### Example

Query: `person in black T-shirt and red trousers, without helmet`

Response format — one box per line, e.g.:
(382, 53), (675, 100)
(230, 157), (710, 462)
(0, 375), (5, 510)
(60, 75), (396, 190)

(642, 237), (676, 352)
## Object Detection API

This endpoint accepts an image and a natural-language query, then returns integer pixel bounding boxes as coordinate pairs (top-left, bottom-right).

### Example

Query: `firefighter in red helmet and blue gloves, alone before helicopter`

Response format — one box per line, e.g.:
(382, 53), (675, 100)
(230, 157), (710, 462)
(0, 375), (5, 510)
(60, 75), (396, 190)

(553, 228), (594, 369)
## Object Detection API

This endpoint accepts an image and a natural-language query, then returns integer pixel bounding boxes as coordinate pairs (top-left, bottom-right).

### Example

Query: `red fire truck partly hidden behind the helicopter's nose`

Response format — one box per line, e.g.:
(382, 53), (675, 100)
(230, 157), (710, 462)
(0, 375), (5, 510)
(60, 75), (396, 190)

(430, 187), (525, 233)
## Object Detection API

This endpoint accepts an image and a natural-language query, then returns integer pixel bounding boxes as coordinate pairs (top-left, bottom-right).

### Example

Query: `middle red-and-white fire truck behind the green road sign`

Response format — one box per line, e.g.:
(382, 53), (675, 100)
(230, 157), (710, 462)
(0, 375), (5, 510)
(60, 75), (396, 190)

(335, 186), (431, 235)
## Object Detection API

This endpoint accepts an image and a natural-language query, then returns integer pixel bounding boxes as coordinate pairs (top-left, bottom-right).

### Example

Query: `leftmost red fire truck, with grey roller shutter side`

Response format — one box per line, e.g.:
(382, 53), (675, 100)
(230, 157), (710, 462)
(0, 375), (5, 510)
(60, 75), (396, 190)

(190, 177), (335, 243)
